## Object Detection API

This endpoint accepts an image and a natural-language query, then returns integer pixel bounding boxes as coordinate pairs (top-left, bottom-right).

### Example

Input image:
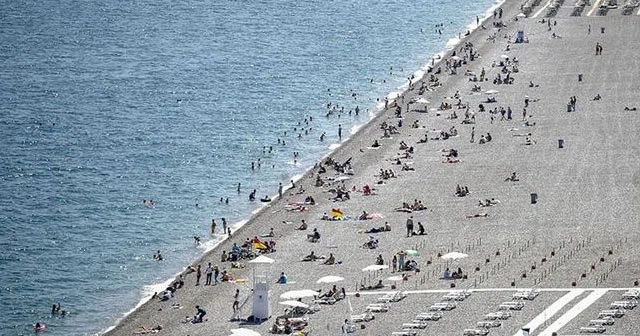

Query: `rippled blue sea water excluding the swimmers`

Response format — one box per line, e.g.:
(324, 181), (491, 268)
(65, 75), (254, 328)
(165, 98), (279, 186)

(0, 0), (493, 335)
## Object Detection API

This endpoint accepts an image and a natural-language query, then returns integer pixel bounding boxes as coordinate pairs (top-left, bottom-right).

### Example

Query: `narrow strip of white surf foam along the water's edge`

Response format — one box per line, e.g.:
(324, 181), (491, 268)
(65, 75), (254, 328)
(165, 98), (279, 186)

(102, 0), (516, 336)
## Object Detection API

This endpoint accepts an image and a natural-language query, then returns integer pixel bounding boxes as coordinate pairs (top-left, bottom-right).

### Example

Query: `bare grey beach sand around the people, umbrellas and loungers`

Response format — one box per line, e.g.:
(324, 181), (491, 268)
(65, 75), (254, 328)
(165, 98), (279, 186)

(102, 1), (640, 335)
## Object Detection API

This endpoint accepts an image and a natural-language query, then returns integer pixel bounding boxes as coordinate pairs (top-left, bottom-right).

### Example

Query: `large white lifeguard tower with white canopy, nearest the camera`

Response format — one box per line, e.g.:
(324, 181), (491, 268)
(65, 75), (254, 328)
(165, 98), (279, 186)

(249, 256), (275, 322)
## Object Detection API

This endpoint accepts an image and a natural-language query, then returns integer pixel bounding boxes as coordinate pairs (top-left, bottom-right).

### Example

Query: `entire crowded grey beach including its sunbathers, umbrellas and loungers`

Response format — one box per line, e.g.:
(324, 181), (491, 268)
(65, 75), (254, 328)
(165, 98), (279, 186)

(106, 0), (640, 336)
